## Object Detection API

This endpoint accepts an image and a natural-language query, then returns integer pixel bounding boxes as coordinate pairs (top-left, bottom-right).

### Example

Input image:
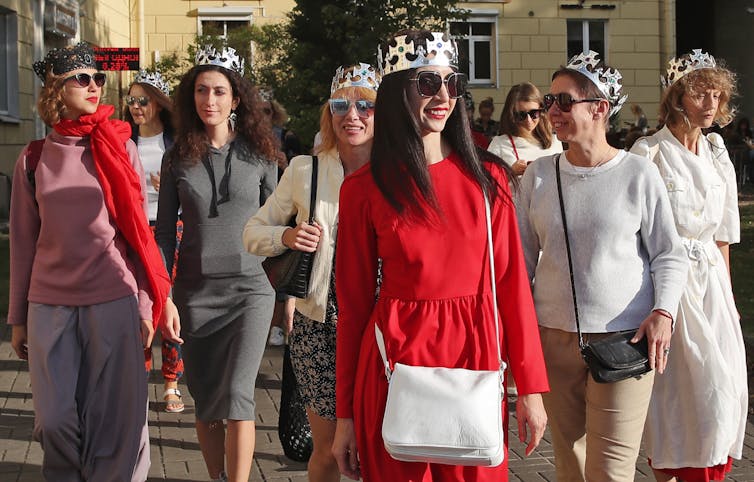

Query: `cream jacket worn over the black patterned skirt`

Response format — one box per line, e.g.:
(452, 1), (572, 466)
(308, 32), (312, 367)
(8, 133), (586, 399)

(243, 150), (343, 322)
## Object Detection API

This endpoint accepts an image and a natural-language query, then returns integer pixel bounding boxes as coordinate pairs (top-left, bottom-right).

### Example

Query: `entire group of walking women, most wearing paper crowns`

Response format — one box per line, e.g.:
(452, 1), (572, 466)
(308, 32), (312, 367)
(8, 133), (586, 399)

(8, 25), (754, 482)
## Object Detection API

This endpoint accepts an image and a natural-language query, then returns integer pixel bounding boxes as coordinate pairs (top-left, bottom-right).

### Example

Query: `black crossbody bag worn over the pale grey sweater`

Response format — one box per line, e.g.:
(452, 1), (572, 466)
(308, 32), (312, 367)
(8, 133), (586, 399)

(555, 155), (651, 383)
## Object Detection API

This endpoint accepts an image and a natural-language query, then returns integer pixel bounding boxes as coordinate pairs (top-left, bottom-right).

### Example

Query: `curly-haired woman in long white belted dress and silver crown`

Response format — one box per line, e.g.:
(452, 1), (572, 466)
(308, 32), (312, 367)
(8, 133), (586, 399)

(631, 50), (749, 482)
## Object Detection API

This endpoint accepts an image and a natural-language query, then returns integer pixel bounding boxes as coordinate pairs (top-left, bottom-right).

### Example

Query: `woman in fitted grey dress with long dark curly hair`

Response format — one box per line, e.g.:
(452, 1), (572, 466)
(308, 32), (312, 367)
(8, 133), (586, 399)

(155, 46), (278, 482)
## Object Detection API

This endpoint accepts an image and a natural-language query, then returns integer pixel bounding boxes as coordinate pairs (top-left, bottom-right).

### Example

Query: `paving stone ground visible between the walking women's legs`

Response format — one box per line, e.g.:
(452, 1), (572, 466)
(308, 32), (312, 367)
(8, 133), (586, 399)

(0, 320), (754, 482)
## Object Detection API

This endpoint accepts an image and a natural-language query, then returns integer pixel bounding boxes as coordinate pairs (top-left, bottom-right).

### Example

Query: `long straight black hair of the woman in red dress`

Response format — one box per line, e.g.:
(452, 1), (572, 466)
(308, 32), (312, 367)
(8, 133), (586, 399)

(370, 31), (515, 219)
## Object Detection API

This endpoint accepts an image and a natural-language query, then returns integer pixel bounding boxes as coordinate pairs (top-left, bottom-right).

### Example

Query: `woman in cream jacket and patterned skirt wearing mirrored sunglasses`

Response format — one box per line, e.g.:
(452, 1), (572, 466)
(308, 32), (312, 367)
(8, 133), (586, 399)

(244, 63), (380, 482)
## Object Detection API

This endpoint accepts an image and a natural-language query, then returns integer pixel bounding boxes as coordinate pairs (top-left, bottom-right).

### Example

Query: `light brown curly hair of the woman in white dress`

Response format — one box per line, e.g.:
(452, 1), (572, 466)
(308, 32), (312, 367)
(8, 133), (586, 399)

(659, 64), (737, 127)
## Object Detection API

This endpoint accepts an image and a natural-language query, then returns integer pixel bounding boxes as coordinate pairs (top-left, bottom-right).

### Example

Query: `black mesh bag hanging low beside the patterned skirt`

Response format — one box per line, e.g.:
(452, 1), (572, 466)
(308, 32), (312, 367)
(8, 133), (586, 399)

(278, 345), (314, 462)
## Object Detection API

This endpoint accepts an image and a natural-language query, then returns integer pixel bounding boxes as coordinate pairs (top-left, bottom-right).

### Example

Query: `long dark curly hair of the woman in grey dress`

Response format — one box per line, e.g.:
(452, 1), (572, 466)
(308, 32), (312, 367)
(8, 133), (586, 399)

(172, 65), (279, 163)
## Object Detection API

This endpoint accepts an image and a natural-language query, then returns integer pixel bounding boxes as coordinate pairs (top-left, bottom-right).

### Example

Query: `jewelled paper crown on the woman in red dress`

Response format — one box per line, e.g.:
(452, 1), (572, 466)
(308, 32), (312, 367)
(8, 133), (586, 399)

(377, 32), (458, 77)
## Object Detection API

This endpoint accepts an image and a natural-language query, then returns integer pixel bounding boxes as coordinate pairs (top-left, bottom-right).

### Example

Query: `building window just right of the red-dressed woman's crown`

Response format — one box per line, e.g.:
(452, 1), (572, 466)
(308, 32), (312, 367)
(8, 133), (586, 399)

(450, 12), (497, 85)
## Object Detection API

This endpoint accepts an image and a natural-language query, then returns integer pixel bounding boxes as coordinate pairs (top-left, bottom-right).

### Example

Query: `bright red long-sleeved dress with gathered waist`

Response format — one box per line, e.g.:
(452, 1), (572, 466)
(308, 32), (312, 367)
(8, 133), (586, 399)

(335, 155), (549, 482)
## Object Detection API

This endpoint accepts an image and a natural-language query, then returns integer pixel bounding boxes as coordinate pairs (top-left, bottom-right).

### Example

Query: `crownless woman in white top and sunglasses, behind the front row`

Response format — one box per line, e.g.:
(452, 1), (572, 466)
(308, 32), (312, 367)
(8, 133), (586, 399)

(487, 82), (563, 176)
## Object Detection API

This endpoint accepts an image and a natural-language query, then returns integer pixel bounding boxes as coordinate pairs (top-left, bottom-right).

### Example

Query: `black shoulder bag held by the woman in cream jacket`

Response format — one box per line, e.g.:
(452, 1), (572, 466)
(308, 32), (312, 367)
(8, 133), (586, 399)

(262, 156), (319, 298)
